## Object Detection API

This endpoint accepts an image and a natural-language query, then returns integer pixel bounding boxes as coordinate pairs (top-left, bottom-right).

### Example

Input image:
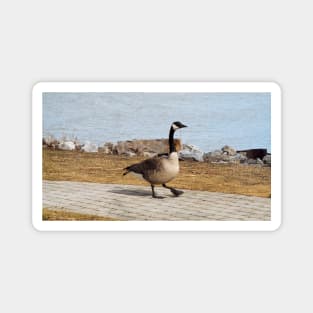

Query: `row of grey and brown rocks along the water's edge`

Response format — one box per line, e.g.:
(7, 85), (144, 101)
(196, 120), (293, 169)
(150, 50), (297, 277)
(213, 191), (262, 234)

(42, 136), (271, 166)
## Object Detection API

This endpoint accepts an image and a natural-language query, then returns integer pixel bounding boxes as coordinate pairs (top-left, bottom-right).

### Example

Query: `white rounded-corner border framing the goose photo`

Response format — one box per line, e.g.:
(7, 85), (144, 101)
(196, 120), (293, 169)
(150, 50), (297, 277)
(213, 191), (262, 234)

(32, 82), (281, 231)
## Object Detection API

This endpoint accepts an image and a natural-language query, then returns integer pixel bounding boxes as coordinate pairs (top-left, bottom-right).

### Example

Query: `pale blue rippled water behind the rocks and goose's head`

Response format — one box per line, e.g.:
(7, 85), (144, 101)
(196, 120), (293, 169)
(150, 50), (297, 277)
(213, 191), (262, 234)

(43, 93), (271, 151)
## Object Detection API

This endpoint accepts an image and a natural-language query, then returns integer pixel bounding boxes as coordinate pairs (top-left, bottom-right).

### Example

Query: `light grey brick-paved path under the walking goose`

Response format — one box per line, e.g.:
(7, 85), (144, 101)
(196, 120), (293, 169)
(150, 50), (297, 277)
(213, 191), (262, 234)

(43, 181), (271, 221)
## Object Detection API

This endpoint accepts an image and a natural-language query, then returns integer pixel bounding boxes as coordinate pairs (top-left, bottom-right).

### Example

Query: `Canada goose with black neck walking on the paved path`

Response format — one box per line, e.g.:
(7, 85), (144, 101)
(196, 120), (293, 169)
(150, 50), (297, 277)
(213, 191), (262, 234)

(123, 122), (187, 198)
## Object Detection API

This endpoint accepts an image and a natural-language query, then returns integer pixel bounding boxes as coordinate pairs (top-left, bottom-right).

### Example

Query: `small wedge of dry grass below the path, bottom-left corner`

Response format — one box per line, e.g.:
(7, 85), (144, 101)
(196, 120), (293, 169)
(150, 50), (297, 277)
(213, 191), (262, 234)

(42, 208), (115, 221)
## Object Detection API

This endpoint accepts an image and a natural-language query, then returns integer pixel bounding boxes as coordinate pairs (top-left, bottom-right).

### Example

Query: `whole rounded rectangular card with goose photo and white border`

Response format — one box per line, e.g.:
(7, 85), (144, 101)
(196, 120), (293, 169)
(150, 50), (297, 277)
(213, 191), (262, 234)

(32, 82), (281, 231)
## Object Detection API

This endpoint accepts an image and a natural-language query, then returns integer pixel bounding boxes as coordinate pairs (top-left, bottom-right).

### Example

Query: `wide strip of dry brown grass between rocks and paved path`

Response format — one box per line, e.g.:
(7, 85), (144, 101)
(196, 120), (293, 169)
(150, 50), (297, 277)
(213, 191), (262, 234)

(43, 149), (271, 197)
